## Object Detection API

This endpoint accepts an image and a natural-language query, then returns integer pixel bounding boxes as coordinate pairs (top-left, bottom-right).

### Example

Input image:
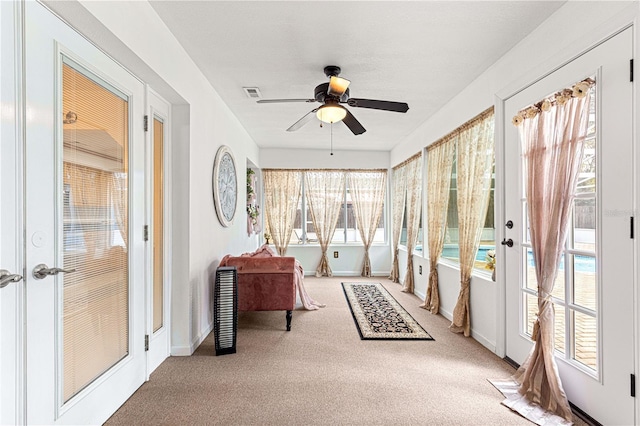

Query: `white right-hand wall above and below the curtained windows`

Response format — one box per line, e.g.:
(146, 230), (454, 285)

(390, 2), (639, 356)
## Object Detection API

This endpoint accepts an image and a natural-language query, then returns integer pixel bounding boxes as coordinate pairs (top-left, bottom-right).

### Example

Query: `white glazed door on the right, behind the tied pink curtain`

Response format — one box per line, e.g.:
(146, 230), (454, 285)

(504, 29), (635, 424)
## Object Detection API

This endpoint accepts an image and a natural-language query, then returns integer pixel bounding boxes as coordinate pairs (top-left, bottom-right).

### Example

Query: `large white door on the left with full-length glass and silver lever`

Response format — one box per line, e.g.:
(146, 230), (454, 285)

(23, 1), (146, 424)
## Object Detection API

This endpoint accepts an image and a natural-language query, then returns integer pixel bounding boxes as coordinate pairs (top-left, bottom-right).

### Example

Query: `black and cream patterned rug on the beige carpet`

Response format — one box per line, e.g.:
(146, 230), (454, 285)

(342, 283), (433, 340)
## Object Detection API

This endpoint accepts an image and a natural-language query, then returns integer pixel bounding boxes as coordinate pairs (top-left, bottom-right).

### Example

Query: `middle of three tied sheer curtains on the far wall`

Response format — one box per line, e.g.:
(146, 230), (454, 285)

(304, 170), (346, 277)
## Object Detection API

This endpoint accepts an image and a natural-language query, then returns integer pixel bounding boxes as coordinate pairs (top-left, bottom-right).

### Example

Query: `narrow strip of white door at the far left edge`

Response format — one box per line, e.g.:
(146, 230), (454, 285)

(0, 1), (25, 424)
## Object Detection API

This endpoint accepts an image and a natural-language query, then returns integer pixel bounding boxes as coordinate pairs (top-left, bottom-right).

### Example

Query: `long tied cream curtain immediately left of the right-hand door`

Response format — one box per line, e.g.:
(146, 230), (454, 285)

(449, 108), (494, 337)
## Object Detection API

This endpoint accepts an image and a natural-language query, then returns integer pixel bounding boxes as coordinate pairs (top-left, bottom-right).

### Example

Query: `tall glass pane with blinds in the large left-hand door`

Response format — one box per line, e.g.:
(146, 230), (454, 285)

(62, 63), (129, 401)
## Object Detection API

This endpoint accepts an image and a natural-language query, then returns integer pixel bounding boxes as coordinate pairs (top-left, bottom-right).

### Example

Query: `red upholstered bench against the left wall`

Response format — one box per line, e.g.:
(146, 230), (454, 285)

(220, 256), (296, 331)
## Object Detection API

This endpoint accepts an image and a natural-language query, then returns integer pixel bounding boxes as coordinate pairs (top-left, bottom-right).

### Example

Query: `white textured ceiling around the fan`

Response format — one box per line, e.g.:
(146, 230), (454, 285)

(150, 0), (564, 151)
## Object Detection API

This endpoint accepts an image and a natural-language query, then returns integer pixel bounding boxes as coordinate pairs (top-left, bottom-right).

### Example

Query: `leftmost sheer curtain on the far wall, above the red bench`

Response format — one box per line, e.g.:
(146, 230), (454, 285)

(263, 169), (302, 256)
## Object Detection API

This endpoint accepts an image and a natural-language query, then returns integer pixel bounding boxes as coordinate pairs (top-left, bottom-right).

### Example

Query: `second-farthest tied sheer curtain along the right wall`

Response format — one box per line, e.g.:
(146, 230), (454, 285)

(402, 153), (422, 293)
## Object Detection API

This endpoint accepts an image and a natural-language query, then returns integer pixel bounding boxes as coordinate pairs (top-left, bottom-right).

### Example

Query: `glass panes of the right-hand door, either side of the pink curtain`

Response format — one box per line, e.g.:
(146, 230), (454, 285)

(523, 87), (599, 373)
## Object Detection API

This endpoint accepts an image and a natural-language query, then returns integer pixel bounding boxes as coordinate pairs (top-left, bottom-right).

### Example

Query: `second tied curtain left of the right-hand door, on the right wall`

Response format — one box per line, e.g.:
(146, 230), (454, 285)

(421, 139), (456, 314)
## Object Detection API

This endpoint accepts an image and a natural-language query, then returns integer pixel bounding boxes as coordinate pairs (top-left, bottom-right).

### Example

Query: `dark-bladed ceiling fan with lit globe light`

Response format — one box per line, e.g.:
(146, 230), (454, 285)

(257, 65), (409, 135)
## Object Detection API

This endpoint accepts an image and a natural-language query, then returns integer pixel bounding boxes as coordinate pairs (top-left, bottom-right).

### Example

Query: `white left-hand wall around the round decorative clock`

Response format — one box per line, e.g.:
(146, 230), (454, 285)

(74, 1), (259, 355)
